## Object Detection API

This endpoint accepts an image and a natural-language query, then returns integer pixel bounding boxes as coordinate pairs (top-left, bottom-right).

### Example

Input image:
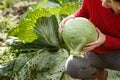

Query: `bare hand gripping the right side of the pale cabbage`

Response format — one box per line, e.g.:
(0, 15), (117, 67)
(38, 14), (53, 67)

(83, 28), (106, 51)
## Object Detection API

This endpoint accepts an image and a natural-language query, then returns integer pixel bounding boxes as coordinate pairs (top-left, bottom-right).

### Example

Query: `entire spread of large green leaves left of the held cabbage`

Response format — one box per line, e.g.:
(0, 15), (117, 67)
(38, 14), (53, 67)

(0, 0), (79, 80)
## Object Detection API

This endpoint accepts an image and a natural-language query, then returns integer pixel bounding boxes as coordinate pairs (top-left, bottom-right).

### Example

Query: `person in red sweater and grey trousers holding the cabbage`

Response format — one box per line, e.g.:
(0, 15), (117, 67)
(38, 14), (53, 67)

(59, 0), (120, 80)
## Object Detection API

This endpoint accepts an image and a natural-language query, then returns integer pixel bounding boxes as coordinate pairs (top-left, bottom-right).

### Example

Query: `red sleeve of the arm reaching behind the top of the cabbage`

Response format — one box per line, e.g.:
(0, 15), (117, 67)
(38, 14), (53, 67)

(74, 0), (89, 18)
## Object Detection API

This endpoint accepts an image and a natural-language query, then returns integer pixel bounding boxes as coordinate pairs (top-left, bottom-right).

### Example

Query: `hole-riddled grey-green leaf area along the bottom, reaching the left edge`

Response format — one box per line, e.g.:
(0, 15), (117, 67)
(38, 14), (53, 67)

(0, 49), (68, 80)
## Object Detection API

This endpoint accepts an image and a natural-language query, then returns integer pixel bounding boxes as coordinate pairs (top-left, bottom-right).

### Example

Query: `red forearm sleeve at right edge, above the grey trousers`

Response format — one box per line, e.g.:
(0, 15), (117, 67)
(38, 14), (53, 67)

(92, 35), (120, 54)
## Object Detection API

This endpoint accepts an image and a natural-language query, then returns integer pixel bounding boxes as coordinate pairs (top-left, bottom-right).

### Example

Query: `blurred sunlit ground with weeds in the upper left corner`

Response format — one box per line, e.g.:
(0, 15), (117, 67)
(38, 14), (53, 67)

(0, 0), (39, 53)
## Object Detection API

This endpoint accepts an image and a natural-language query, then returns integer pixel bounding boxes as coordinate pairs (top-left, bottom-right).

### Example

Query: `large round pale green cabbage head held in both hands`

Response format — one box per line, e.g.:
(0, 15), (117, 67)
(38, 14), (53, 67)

(62, 17), (98, 56)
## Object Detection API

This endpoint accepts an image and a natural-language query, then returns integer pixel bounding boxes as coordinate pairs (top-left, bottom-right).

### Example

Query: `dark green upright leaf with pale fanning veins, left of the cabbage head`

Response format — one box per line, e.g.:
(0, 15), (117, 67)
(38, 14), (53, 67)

(35, 16), (59, 47)
